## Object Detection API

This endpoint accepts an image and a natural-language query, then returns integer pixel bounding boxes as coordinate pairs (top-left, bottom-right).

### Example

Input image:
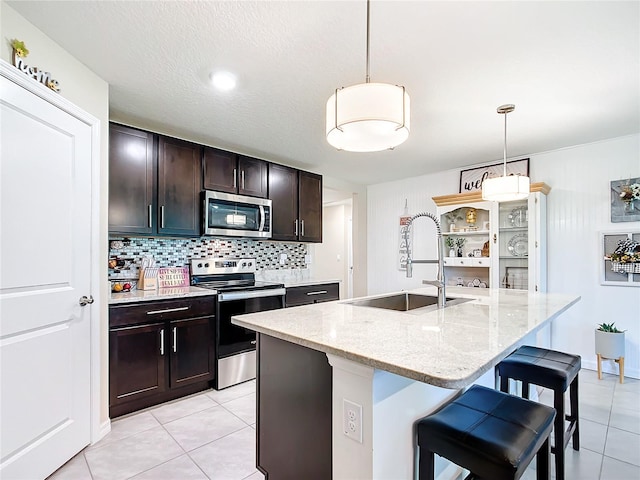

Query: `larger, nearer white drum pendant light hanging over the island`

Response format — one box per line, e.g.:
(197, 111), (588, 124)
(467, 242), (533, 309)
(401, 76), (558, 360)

(326, 0), (410, 152)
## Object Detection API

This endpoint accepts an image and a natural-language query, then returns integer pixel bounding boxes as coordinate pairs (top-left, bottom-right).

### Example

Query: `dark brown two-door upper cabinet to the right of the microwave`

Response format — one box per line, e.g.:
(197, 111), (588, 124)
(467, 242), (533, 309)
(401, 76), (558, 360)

(269, 163), (322, 243)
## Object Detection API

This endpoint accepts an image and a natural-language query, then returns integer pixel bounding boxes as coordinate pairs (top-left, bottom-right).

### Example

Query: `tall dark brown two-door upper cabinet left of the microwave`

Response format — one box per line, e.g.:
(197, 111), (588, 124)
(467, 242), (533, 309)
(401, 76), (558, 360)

(109, 124), (202, 237)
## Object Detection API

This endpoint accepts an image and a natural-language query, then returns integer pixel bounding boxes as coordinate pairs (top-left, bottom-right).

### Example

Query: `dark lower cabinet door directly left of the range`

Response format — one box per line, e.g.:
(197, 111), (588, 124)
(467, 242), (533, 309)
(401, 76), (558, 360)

(170, 317), (215, 388)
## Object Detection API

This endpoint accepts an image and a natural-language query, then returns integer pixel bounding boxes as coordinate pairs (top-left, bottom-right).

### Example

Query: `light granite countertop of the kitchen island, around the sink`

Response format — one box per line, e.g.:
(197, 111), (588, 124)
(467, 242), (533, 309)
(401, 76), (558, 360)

(232, 287), (580, 388)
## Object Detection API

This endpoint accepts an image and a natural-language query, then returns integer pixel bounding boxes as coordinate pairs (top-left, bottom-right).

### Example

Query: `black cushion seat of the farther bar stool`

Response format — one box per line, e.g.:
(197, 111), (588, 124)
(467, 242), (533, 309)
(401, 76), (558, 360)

(498, 345), (581, 392)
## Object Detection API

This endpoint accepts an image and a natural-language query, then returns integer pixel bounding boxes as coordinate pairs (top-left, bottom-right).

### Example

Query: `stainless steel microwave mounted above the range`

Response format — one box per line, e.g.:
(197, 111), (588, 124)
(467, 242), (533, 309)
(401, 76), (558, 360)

(202, 190), (271, 238)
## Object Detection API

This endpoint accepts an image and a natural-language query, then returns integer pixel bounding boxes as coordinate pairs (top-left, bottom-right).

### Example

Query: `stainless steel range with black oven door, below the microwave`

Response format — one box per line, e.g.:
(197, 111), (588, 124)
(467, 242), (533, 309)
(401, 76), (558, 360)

(191, 258), (286, 390)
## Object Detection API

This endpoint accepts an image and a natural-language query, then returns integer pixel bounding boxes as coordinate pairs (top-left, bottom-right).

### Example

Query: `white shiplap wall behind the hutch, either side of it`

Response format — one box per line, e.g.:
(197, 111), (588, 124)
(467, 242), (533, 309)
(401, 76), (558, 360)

(367, 135), (640, 378)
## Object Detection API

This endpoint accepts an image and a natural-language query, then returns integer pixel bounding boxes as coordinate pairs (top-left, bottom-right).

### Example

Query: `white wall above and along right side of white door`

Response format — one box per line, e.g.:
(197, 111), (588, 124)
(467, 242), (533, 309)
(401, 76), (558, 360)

(0, 2), (109, 422)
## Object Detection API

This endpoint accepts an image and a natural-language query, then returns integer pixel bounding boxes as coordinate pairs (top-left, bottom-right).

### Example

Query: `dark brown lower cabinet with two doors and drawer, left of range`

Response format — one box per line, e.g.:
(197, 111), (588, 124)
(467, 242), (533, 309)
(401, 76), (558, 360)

(109, 297), (215, 418)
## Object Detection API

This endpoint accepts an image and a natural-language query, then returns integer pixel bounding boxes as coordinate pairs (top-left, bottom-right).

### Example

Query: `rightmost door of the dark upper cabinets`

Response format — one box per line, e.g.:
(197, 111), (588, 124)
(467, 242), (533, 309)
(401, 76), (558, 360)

(298, 171), (322, 243)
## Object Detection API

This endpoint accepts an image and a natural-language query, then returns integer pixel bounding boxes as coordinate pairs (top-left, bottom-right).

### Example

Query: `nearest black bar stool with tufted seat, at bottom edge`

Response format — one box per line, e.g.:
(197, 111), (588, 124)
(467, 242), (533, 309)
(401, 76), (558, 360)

(416, 385), (556, 480)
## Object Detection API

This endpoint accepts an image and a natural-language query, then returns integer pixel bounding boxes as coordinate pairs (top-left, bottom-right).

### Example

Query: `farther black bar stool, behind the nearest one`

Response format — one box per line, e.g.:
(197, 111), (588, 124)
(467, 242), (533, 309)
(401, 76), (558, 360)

(496, 345), (581, 480)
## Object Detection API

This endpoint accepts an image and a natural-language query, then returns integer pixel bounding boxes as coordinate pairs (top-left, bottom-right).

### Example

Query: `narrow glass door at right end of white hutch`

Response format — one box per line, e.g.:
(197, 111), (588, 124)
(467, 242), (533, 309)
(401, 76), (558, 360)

(498, 199), (533, 290)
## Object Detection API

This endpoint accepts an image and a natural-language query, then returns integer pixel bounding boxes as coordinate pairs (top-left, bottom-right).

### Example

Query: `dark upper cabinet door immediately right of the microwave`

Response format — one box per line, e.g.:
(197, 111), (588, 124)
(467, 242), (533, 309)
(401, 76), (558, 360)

(269, 163), (298, 241)
